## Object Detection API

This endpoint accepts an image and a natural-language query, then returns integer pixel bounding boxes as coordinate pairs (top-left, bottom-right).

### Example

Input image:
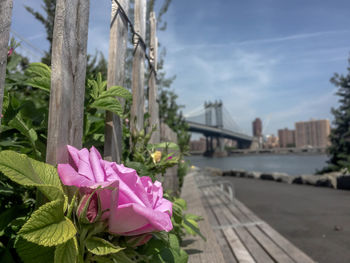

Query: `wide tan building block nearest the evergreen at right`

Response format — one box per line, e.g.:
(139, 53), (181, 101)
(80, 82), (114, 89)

(295, 120), (331, 148)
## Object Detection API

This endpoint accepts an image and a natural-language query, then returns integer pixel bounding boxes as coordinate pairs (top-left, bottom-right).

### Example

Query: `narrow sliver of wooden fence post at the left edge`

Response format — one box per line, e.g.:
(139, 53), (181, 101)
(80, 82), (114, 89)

(0, 0), (13, 128)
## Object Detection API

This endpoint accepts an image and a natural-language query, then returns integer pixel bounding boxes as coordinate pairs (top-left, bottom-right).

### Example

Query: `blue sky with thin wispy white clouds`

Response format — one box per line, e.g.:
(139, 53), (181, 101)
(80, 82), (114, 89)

(12, 0), (350, 134)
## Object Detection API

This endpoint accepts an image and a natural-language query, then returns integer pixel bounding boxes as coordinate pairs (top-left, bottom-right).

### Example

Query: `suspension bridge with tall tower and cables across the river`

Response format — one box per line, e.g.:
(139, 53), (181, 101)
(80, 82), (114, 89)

(184, 101), (253, 155)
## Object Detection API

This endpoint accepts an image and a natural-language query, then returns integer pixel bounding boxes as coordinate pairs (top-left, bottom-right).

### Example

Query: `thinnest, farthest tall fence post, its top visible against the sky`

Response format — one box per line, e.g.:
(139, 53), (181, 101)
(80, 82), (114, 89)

(148, 12), (160, 143)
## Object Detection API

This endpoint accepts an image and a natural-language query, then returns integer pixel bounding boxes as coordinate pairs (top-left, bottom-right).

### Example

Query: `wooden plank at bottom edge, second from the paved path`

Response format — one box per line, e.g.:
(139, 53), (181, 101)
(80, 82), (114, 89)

(247, 226), (294, 263)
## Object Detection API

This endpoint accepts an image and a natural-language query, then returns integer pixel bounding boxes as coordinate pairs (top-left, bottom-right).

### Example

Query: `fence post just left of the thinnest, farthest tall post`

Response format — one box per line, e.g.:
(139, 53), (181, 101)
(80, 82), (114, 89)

(130, 0), (146, 136)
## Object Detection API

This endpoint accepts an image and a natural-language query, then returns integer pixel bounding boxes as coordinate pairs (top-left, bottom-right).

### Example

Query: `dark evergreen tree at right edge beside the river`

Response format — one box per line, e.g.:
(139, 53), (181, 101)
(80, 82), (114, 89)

(325, 59), (350, 171)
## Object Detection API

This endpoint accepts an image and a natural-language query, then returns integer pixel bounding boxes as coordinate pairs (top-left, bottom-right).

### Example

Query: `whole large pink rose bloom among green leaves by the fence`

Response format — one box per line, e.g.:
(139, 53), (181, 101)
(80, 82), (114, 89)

(58, 146), (173, 236)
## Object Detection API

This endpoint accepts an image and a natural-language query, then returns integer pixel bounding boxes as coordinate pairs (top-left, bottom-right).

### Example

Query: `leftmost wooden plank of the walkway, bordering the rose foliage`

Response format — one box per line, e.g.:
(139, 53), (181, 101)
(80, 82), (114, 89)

(181, 173), (225, 263)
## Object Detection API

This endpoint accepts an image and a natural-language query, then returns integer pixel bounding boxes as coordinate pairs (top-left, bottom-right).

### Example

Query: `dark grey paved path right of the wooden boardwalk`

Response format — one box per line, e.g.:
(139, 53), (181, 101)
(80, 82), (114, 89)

(226, 177), (350, 263)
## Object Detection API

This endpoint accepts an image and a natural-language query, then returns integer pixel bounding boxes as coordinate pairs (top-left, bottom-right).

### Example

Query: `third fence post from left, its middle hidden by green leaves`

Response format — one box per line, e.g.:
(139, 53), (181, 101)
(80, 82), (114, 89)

(104, 0), (129, 163)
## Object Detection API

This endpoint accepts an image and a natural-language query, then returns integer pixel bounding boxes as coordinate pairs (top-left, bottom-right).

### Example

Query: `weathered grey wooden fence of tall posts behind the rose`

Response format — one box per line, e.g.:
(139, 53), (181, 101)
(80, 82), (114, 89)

(0, 0), (175, 191)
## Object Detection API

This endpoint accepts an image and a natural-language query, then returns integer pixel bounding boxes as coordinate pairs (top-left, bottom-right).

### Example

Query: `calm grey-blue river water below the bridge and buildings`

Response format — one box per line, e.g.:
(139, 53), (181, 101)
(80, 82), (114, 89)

(187, 154), (328, 175)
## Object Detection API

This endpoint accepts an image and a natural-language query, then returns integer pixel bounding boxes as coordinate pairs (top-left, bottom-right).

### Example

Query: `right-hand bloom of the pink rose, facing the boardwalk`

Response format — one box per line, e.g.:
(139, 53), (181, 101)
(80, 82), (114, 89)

(107, 163), (173, 236)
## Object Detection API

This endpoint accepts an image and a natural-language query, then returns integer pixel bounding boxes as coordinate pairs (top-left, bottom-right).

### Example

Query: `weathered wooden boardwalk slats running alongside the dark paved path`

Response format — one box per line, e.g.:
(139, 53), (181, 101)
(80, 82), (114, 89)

(183, 173), (314, 263)
